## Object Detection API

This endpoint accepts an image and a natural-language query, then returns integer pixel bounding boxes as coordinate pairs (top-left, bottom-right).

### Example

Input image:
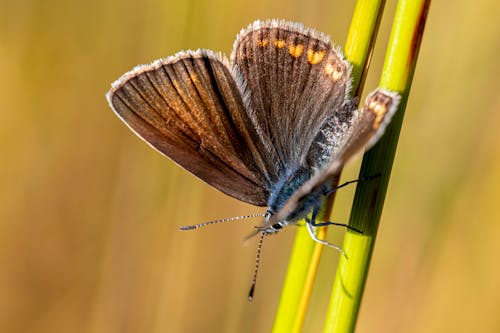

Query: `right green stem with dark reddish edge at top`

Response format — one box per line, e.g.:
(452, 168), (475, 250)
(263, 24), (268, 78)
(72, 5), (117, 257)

(324, 0), (430, 333)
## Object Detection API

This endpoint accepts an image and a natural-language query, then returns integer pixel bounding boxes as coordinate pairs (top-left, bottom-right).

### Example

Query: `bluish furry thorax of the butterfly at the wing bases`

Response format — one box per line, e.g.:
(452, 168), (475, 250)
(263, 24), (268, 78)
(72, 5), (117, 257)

(262, 167), (328, 234)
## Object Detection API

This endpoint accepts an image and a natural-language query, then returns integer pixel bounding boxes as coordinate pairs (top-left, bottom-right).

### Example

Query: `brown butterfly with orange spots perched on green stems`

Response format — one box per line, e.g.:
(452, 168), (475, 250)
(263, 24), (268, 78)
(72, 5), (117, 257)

(107, 20), (399, 250)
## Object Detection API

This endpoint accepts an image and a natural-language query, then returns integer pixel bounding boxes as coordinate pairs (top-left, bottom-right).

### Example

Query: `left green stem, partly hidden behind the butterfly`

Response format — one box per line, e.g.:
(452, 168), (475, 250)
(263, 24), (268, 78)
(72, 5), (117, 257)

(273, 0), (385, 333)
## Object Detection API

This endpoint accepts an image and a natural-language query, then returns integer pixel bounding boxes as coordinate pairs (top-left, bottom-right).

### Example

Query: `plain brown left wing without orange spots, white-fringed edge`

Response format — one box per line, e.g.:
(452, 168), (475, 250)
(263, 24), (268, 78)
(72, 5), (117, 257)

(107, 50), (269, 206)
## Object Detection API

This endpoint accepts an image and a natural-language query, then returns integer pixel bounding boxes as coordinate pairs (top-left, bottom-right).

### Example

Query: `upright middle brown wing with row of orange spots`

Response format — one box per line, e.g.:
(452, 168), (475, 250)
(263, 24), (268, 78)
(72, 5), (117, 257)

(231, 20), (352, 175)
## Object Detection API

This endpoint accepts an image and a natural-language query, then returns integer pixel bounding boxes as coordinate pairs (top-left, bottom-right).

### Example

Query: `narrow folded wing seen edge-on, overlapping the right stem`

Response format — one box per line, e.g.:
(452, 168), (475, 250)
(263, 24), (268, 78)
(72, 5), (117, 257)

(263, 89), (400, 227)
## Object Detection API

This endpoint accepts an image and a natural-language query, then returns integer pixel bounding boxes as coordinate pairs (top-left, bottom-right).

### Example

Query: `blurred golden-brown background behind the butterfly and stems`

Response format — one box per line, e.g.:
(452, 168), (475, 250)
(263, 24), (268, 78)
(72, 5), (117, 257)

(0, 0), (500, 333)
